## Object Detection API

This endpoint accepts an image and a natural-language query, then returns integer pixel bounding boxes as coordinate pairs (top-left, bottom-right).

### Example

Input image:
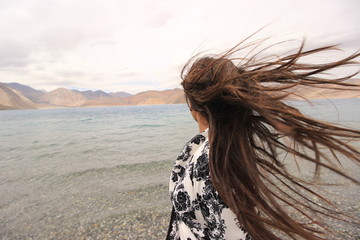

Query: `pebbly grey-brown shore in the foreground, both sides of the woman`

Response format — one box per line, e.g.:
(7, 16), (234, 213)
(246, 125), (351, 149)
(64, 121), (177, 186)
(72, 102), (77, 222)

(0, 158), (360, 240)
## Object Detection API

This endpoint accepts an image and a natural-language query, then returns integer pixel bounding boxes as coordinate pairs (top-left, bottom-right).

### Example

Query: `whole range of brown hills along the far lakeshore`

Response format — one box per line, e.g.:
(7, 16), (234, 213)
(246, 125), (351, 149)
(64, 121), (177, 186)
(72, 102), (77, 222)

(0, 79), (360, 110)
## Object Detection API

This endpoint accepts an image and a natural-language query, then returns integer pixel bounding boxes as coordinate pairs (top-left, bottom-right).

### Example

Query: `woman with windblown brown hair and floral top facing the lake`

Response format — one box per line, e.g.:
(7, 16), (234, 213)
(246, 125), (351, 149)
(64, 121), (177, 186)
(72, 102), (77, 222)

(167, 39), (360, 240)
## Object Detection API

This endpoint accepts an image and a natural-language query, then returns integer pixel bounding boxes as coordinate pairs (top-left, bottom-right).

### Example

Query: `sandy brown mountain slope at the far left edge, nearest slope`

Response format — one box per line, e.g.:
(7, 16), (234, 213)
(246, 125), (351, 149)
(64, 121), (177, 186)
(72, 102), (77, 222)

(0, 83), (37, 109)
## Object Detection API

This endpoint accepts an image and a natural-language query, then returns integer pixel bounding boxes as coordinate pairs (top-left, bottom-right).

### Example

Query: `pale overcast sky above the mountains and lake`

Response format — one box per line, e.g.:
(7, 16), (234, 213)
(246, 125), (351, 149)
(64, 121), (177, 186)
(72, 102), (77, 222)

(0, 0), (360, 94)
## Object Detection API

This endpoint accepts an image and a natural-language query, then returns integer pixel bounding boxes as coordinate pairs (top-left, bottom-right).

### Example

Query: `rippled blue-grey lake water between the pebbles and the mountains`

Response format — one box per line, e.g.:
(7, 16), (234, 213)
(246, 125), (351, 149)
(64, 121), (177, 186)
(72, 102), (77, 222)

(0, 99), (360, 239)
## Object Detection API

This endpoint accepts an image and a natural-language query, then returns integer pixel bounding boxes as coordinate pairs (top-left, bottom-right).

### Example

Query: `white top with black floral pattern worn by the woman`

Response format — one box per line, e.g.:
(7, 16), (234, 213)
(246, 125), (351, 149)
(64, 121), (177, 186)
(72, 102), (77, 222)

(168, 130), (251, 240)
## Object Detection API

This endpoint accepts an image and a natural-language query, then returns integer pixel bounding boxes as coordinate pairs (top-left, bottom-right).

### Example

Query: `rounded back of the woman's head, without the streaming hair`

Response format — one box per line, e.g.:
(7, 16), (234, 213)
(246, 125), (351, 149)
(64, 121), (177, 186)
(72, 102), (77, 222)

(181, 57), (255, 130)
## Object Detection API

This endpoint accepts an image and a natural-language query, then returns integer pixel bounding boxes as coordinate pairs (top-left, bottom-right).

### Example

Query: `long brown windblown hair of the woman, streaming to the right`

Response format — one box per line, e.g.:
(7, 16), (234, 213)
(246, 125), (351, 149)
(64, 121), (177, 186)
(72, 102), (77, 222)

(182, 39), (360, 240)
